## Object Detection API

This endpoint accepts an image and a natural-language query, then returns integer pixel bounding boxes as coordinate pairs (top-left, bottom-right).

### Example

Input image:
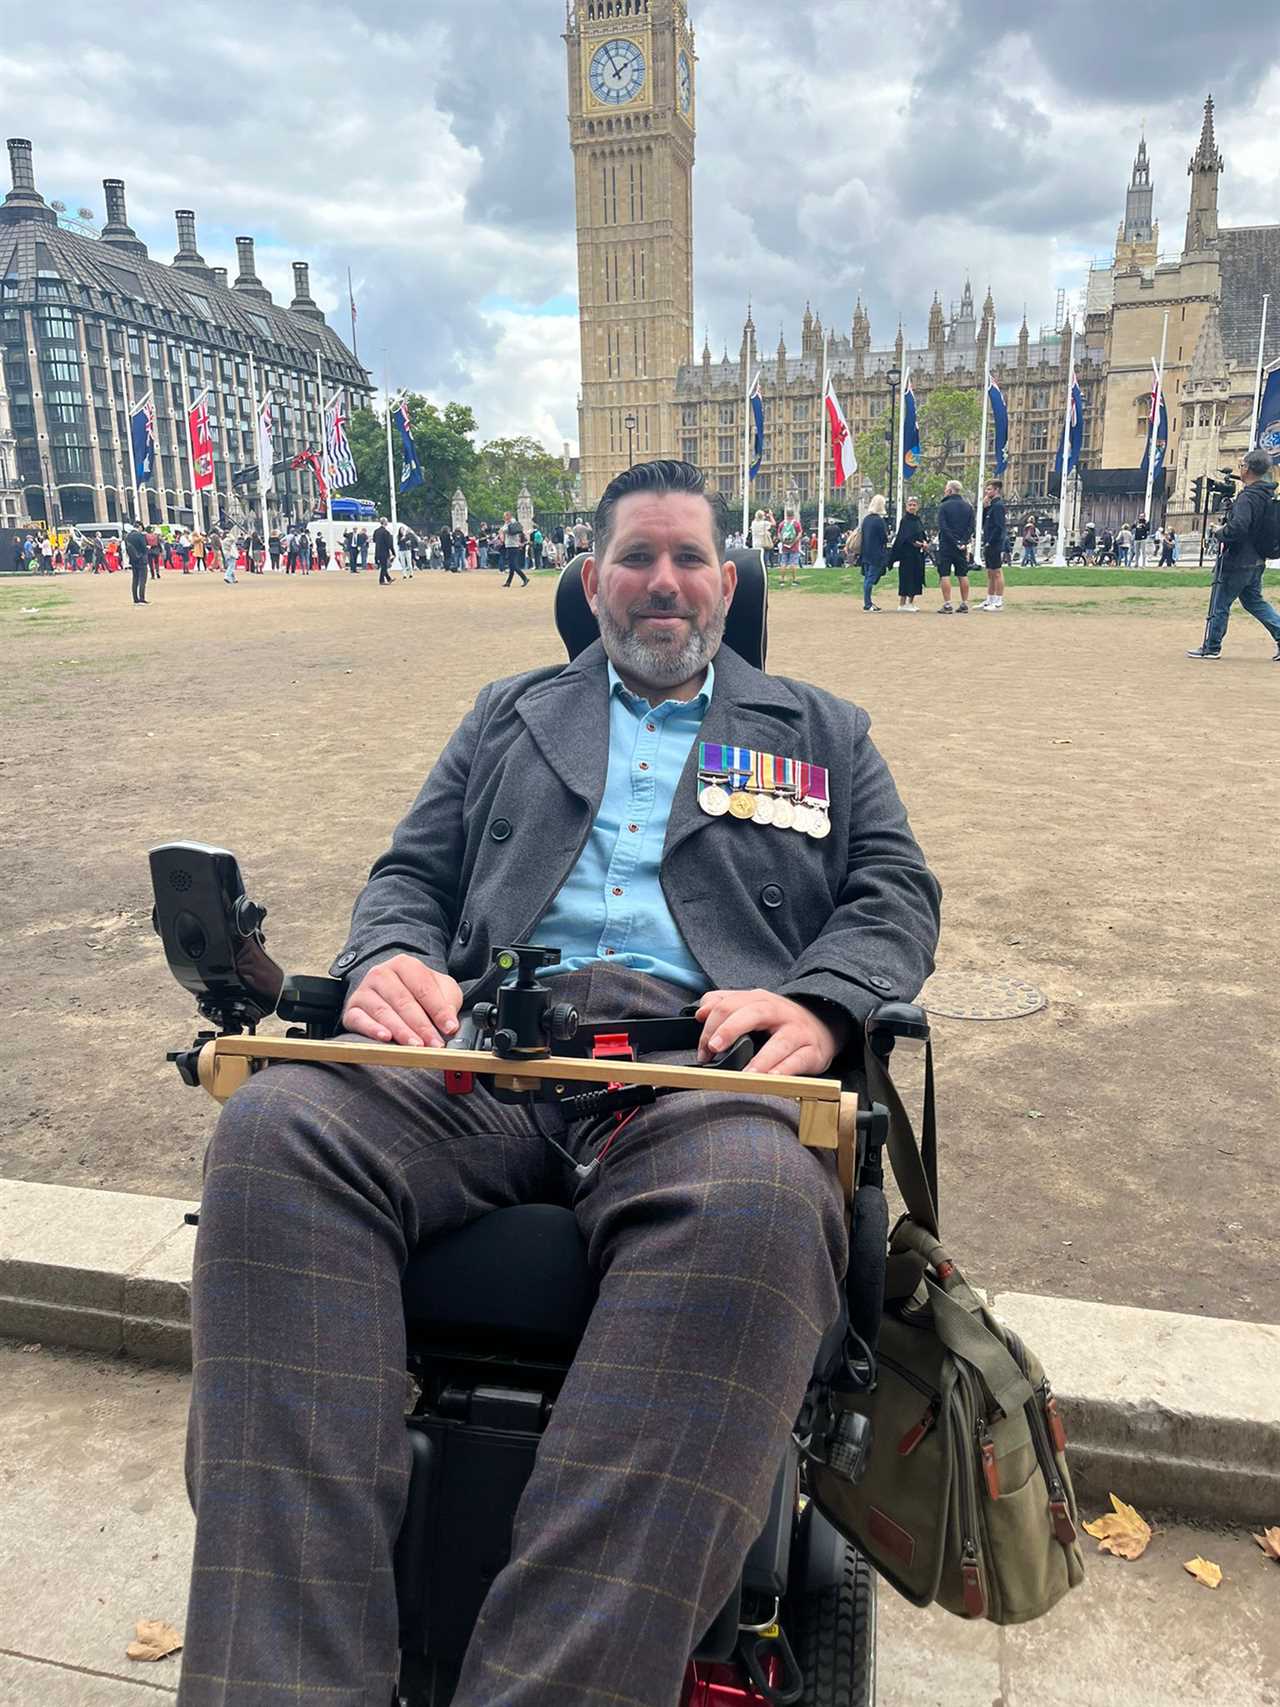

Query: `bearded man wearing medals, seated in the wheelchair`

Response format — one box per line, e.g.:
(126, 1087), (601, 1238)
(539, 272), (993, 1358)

(179, 461), (939, 1707)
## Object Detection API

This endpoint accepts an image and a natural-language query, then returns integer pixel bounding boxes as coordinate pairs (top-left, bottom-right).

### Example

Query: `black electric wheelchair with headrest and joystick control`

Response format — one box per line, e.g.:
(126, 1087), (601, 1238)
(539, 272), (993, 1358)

(150, 551), (923, 1707)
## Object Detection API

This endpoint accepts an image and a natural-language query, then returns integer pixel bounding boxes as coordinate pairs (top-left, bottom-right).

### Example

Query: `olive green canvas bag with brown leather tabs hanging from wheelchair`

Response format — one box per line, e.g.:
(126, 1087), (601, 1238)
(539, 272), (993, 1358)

(806, 1024), (1084, 1623)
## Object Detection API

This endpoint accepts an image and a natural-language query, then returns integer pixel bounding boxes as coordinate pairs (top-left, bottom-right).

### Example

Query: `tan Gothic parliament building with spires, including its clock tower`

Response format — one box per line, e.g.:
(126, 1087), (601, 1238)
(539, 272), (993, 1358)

(565, 0), (1280, 526)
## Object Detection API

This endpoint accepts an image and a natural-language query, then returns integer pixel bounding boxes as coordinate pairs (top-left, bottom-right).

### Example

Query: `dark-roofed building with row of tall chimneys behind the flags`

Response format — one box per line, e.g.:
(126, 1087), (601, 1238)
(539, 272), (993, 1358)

(0, 138), (372, 526)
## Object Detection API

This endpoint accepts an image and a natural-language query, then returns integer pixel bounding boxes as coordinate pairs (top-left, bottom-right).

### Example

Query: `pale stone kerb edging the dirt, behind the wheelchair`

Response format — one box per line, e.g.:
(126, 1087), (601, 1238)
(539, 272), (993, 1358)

(0, 1180), (1280, 1526)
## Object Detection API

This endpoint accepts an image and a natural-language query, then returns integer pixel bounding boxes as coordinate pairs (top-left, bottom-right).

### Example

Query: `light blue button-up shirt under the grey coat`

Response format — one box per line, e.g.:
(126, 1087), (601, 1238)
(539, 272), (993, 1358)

(538, 664), (715, 995)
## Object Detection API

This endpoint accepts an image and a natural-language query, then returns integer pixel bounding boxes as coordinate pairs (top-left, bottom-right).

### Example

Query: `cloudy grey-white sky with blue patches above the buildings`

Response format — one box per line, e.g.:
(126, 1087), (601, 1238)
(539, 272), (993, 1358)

(0, 0), (1280, 449)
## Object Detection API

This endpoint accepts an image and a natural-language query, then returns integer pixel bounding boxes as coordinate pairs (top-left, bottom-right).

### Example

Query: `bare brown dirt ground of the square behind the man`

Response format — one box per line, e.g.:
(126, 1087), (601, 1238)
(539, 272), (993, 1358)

(0, 574), (1280, 1321)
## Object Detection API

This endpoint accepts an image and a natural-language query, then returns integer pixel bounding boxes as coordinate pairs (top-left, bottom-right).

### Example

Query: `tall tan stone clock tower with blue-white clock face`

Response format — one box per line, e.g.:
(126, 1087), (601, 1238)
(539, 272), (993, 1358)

(565, 0), (696, 505)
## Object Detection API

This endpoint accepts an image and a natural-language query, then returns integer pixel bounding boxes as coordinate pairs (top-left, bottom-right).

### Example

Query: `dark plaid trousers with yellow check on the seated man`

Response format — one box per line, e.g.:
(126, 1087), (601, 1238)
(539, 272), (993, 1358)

(177, 966), (847, 1707)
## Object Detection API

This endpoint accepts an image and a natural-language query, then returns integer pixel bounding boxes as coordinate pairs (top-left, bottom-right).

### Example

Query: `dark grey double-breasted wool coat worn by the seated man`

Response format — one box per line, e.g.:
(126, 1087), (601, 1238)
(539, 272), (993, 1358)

(331, 640), (940, 1031)
